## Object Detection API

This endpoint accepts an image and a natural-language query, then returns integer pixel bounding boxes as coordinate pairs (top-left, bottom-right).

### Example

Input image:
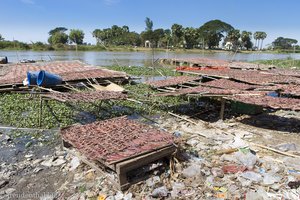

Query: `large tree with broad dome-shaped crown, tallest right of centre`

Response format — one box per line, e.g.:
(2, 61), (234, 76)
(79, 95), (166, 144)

(198, 20), (234, 49)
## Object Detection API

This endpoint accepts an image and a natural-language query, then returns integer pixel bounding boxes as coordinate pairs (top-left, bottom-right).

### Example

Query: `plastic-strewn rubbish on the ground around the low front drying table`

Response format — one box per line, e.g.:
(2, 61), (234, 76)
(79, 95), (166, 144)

(47, 111), (300, 200)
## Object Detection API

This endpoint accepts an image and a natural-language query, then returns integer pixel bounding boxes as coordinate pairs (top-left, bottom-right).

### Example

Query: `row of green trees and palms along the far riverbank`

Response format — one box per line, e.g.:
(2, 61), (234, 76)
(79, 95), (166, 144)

(0, 17), (299, 50)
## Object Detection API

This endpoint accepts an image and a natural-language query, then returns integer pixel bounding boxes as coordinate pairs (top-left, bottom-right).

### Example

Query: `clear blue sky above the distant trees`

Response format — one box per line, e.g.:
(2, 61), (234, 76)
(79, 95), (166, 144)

(0, 0), (300, 44)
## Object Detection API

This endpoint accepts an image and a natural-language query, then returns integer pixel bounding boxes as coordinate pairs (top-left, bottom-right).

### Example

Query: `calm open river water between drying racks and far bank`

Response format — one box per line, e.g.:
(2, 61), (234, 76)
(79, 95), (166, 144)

(0, 51), (300, 66)
